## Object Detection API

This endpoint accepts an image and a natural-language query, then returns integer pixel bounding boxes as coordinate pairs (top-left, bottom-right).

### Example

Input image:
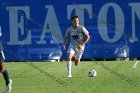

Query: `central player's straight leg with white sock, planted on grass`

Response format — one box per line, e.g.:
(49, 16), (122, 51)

(67, 47), (74, 77)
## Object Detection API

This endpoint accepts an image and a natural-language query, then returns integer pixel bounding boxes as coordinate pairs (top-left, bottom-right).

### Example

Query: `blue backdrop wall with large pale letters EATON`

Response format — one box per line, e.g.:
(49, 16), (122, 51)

(0, 0), (140, 61)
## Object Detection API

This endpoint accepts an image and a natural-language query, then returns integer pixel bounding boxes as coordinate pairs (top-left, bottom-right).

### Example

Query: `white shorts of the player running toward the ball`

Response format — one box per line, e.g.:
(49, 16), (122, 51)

(67, 46), (84, 60)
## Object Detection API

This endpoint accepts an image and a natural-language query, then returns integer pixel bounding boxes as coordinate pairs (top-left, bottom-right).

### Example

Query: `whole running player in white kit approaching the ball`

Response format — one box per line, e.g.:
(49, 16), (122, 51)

(62, 15), (90, 77)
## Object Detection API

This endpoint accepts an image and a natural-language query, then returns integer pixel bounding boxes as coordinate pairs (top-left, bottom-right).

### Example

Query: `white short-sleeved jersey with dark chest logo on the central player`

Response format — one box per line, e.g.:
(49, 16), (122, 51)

(67, 25), (89, 47)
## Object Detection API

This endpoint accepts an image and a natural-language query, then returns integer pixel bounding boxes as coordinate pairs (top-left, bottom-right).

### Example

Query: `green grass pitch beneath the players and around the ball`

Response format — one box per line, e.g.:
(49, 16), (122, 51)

(0, 61), (140, 93)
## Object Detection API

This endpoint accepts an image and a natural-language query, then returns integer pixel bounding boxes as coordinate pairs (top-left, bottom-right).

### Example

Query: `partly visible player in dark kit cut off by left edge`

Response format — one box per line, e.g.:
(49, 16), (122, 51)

(0, 27), (12, 93)
